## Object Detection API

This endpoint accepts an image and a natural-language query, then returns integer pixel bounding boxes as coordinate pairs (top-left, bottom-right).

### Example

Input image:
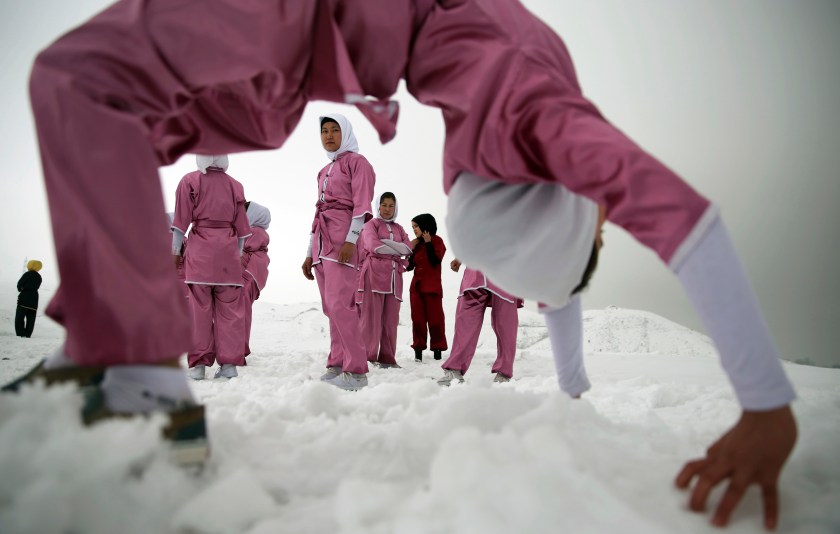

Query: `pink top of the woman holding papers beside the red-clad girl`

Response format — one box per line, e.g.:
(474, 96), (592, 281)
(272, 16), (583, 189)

(356, 217), (411, 302)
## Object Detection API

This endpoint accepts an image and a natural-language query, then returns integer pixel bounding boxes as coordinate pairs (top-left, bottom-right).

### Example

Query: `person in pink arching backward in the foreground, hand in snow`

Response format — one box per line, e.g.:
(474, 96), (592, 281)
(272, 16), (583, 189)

(23, 0), (797, 528)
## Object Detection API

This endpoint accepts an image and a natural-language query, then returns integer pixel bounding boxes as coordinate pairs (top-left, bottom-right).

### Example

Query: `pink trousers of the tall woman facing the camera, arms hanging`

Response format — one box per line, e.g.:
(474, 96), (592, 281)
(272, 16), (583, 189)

(313, 260), (368, 374)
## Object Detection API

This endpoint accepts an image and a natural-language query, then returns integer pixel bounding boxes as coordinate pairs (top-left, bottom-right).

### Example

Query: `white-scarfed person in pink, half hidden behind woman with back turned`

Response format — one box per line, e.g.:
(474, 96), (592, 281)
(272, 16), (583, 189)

(239, 202), (271, 362)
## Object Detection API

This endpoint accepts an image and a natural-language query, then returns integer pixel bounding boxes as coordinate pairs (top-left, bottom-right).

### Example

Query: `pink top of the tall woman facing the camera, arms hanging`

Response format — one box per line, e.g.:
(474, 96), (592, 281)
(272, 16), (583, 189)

(312, 152), (376, 266)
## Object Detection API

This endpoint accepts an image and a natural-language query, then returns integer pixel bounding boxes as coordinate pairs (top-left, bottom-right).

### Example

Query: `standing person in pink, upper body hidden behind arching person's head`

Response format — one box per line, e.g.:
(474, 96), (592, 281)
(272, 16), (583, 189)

(438, 258), (523, 386)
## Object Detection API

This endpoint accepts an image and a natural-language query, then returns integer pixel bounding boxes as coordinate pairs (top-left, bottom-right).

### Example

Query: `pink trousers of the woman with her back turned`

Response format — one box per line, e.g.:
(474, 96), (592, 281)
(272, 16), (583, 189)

(187, 284), (245, 367)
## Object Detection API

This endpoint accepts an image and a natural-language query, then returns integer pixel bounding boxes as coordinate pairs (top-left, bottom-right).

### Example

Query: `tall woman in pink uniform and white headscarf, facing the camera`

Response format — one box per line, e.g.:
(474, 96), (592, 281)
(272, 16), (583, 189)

(302, 113), (376, 390)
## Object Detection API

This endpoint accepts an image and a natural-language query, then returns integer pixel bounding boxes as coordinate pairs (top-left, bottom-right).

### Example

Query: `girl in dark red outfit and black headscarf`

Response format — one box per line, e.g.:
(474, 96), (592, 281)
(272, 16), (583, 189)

(406, 213), (447, 362)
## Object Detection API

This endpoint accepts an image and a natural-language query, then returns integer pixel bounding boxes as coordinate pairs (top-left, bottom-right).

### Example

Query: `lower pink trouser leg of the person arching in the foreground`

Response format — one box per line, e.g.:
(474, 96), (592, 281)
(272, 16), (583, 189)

(30, 72), (190, 365)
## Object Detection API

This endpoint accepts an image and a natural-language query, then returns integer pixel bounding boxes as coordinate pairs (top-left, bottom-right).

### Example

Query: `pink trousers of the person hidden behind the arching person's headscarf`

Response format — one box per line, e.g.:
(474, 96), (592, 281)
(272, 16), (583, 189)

(441, 289), (519, 378)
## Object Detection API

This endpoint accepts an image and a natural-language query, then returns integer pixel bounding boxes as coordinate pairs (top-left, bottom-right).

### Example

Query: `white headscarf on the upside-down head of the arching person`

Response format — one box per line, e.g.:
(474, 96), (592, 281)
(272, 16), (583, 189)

(446, 173), (598, 306)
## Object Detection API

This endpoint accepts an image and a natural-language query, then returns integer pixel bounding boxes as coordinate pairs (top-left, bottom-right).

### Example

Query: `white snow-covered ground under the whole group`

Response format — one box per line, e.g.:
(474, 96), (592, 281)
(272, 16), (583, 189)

(0, 302), (840, 534)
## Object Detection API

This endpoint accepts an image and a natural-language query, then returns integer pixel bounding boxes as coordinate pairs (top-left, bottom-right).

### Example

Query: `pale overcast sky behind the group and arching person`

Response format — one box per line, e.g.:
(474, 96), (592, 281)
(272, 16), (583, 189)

(0, 0), (840, 364)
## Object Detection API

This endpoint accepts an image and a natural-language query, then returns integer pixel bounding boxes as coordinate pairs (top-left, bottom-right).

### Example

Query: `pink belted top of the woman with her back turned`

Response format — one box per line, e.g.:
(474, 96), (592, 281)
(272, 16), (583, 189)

(172, 167), (251, 286)
